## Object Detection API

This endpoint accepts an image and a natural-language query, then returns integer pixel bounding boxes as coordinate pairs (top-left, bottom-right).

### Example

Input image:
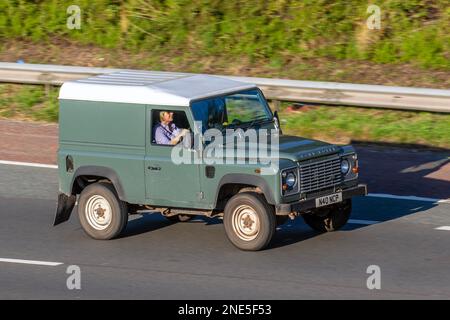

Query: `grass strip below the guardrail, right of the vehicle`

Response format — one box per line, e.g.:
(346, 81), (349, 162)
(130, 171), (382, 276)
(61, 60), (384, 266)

(280, 106), (450, 149)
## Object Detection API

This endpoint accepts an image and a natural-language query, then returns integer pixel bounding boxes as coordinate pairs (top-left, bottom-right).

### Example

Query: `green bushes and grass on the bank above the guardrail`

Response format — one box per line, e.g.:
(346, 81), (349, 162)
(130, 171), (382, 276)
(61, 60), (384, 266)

(0, 0), (450, 69)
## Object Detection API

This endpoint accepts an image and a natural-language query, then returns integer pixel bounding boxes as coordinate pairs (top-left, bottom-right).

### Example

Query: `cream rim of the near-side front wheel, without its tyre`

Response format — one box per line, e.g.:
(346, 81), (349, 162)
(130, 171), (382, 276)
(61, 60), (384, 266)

(232, 205), (260, 241)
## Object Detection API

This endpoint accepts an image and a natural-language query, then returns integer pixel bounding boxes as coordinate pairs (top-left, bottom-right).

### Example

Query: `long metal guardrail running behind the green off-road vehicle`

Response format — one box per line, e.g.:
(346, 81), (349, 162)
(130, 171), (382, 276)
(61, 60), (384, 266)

(0, 62), (450, 113)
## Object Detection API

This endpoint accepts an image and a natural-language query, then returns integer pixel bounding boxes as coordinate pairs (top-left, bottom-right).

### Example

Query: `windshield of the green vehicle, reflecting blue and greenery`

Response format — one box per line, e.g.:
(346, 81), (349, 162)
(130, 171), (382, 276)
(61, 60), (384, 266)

(192, 89), (273, 132)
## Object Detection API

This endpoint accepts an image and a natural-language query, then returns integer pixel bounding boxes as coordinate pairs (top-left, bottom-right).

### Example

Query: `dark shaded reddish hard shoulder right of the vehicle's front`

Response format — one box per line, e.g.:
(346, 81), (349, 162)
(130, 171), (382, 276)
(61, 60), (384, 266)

(352, 141), (450, 199)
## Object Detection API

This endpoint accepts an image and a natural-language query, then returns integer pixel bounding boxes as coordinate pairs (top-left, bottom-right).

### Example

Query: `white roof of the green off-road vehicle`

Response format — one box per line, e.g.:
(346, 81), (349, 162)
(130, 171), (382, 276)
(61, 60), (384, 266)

(59, 70), (256, 106)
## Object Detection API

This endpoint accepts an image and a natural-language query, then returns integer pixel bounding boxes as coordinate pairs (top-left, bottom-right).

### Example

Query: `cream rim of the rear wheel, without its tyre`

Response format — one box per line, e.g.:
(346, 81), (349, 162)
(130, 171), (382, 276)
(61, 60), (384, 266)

(84, 195), (112, 230)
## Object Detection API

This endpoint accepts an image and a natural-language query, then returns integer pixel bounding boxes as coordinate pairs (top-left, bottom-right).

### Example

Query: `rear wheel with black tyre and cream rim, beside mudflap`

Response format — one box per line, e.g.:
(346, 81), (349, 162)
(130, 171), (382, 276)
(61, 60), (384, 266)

(78, 182), (128, 240)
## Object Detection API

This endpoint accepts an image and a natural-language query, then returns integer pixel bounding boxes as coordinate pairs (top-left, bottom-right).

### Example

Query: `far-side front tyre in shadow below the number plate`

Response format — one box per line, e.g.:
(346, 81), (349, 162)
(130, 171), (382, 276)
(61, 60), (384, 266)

(302, 199), (352, 232)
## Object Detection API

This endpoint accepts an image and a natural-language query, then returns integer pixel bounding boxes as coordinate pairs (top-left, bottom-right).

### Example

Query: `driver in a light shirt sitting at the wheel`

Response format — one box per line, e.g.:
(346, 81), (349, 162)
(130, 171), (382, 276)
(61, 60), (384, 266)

(153, 111), (189, 145)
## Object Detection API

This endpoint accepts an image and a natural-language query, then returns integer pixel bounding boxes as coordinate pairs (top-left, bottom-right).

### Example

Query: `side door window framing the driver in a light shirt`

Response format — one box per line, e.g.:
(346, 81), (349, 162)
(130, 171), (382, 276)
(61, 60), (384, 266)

(150, 109), (191, 146)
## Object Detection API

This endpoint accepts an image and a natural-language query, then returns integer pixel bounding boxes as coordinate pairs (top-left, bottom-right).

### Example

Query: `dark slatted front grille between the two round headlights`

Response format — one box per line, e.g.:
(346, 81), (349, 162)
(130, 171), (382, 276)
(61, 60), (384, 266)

(300, 158), (342, 193)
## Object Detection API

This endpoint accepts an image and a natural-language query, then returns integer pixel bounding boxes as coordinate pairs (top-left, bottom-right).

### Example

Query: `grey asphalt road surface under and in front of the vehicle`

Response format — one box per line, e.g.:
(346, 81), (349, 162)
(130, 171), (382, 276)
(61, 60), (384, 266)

(0, 164), (450, 299)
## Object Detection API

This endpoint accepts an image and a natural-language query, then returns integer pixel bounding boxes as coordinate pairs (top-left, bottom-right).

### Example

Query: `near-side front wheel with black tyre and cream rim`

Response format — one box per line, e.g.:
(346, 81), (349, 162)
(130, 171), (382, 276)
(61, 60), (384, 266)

(223, 192), (276, 251)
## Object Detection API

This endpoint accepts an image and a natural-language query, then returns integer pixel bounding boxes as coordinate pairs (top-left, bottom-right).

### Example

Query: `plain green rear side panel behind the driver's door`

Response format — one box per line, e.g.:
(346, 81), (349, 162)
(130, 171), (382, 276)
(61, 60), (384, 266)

(58, 100), (147, 203)
